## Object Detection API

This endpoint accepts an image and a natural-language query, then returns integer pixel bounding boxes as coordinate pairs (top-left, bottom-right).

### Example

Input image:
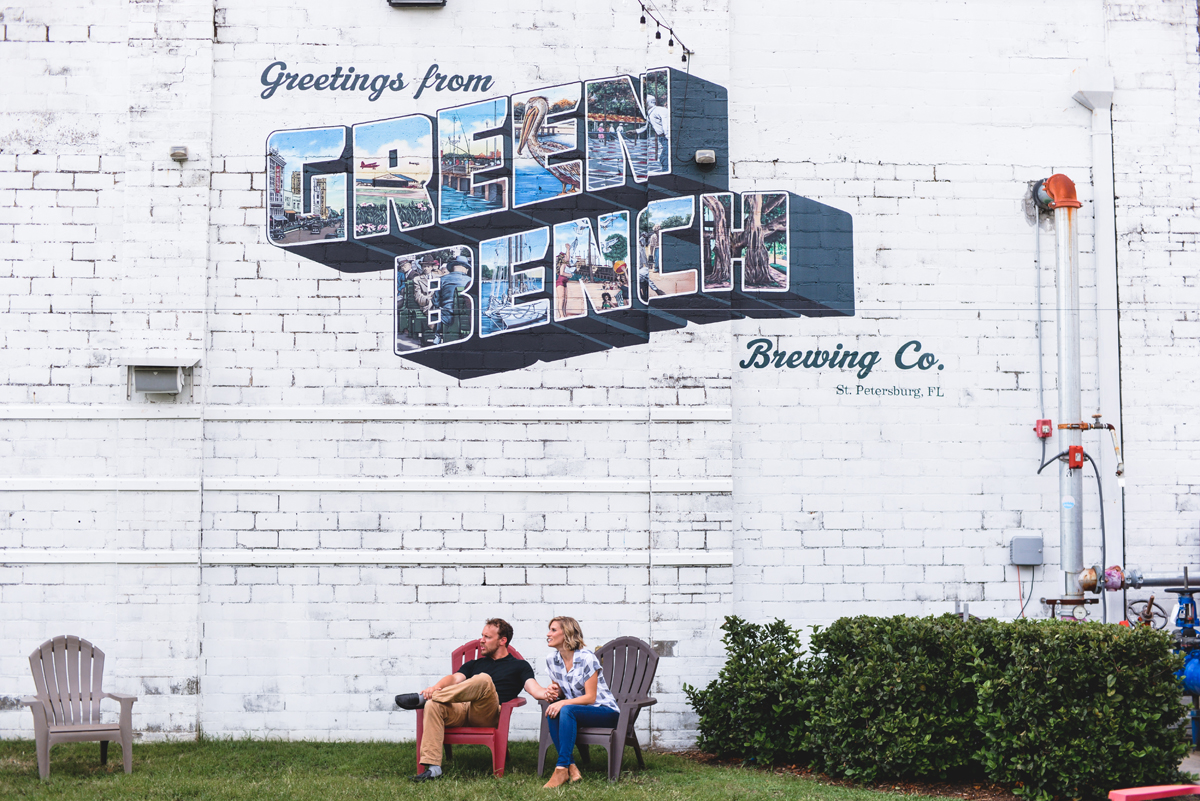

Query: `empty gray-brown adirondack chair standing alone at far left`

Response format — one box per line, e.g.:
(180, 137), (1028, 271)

(20, 637), (137, 778)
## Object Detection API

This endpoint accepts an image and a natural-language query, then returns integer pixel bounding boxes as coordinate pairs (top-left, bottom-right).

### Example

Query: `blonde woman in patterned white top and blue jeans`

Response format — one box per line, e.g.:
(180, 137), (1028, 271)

(546, 618), (620, 788)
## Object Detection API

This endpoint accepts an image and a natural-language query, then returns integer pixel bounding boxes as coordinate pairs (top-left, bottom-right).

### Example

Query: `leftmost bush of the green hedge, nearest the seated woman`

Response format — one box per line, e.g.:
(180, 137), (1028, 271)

(683, 618), (809, 765)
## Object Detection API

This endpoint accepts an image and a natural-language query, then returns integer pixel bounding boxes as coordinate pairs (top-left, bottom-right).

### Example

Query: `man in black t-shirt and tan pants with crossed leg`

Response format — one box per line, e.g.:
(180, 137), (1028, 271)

(396, 618), (558, 782)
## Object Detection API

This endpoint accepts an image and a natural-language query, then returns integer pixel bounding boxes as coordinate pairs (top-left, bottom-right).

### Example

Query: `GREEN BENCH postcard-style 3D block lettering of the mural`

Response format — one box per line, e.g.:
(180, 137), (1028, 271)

(266, 68), (854, 378)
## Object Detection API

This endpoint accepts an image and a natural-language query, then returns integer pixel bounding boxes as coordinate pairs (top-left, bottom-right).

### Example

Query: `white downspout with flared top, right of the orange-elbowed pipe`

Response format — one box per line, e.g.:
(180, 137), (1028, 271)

(1064, 67), (1127, 609)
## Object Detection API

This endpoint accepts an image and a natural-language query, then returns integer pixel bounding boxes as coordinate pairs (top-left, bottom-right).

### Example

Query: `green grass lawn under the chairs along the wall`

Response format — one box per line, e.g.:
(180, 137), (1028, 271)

(0, 740), (960, 801)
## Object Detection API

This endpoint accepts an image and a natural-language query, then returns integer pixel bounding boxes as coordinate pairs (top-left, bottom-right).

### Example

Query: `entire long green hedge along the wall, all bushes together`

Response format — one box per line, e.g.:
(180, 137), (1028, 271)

(684, 615), (1187, 801)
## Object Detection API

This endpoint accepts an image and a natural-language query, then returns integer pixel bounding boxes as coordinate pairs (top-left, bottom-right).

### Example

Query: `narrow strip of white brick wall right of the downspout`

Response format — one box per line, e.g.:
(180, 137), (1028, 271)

(1109, 2), (1200, 574)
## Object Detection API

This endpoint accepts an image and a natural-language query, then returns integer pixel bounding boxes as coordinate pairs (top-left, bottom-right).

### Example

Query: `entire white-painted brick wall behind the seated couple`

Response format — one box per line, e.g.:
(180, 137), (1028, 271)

(0, 0), (1200, 746)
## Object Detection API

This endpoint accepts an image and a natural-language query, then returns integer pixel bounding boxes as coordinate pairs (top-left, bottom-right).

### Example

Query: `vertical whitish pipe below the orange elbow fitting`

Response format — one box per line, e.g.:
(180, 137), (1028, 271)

(1054, 206), (1084, 597)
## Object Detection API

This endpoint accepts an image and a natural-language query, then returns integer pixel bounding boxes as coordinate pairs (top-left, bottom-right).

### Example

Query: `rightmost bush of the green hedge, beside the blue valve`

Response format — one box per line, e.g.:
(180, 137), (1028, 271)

(976, 621), (1187, 801)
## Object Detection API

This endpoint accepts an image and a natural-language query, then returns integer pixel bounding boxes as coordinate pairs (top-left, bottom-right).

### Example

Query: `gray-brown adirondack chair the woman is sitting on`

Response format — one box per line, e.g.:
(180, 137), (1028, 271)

(538, 637), (659, 782)
